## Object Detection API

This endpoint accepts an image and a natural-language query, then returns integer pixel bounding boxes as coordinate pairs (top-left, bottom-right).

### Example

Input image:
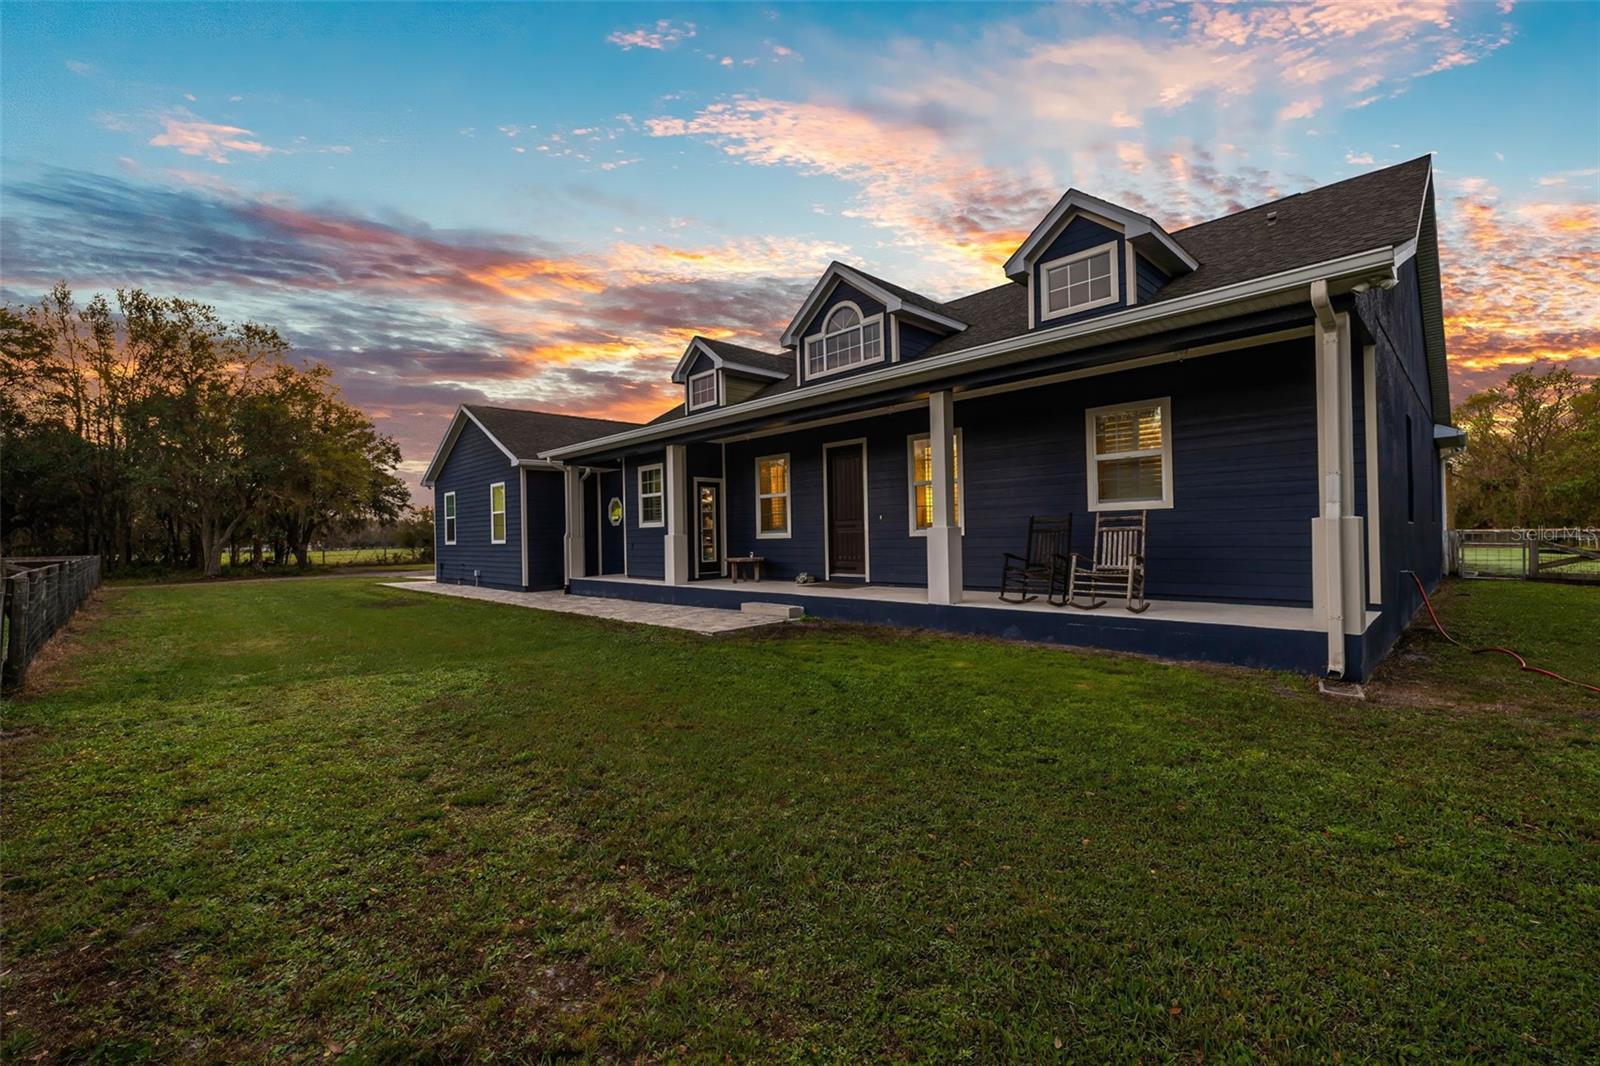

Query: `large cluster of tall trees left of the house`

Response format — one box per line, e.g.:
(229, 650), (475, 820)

(0, 283), (406, 575)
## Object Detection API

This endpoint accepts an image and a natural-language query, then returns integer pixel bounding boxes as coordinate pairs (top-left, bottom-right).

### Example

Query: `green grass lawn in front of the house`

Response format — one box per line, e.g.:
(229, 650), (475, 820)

(0, 579), (1600, 1063)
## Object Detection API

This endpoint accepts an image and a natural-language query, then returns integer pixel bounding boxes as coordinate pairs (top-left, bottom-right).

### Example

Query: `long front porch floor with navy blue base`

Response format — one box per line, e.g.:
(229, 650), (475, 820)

(571, 575), (1379, 680)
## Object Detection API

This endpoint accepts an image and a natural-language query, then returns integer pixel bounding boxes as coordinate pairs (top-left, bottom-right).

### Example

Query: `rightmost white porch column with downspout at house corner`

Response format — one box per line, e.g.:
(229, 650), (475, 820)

(1310, 282), (1365, 677)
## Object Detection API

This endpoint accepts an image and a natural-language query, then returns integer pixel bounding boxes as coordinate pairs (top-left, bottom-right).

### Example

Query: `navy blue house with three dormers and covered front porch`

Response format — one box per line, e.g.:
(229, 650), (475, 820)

(430, 157), (1462, 680)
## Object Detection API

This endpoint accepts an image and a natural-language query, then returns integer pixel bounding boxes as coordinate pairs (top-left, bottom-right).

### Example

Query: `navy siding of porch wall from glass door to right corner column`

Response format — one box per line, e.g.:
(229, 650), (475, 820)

(713, 341), (1317, 605)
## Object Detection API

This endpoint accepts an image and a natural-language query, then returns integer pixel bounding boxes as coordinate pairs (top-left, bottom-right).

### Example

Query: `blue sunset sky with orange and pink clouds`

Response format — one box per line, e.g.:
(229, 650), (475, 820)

(0, 0), (1600, 483)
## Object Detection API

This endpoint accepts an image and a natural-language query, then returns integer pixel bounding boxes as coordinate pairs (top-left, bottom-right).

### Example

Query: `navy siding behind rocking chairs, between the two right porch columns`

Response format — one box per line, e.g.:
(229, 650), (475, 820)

(955, 341), (1317, 605)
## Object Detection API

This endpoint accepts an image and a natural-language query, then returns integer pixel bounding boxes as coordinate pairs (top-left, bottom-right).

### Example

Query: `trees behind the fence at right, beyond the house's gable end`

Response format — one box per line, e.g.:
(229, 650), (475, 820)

(1450, 368), (1600, 530)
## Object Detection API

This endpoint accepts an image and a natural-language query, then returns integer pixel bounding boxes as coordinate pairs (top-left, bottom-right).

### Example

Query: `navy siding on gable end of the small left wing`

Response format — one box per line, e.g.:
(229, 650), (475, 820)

(434, 421), (522, 589)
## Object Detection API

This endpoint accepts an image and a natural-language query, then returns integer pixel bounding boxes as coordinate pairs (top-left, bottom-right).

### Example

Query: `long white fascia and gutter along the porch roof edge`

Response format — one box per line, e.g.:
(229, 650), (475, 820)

(541, 245), (1395, 458)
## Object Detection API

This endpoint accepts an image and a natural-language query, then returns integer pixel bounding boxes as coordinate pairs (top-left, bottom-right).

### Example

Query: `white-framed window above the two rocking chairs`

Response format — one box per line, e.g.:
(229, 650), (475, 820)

(1083, 397), (1173, 511)
